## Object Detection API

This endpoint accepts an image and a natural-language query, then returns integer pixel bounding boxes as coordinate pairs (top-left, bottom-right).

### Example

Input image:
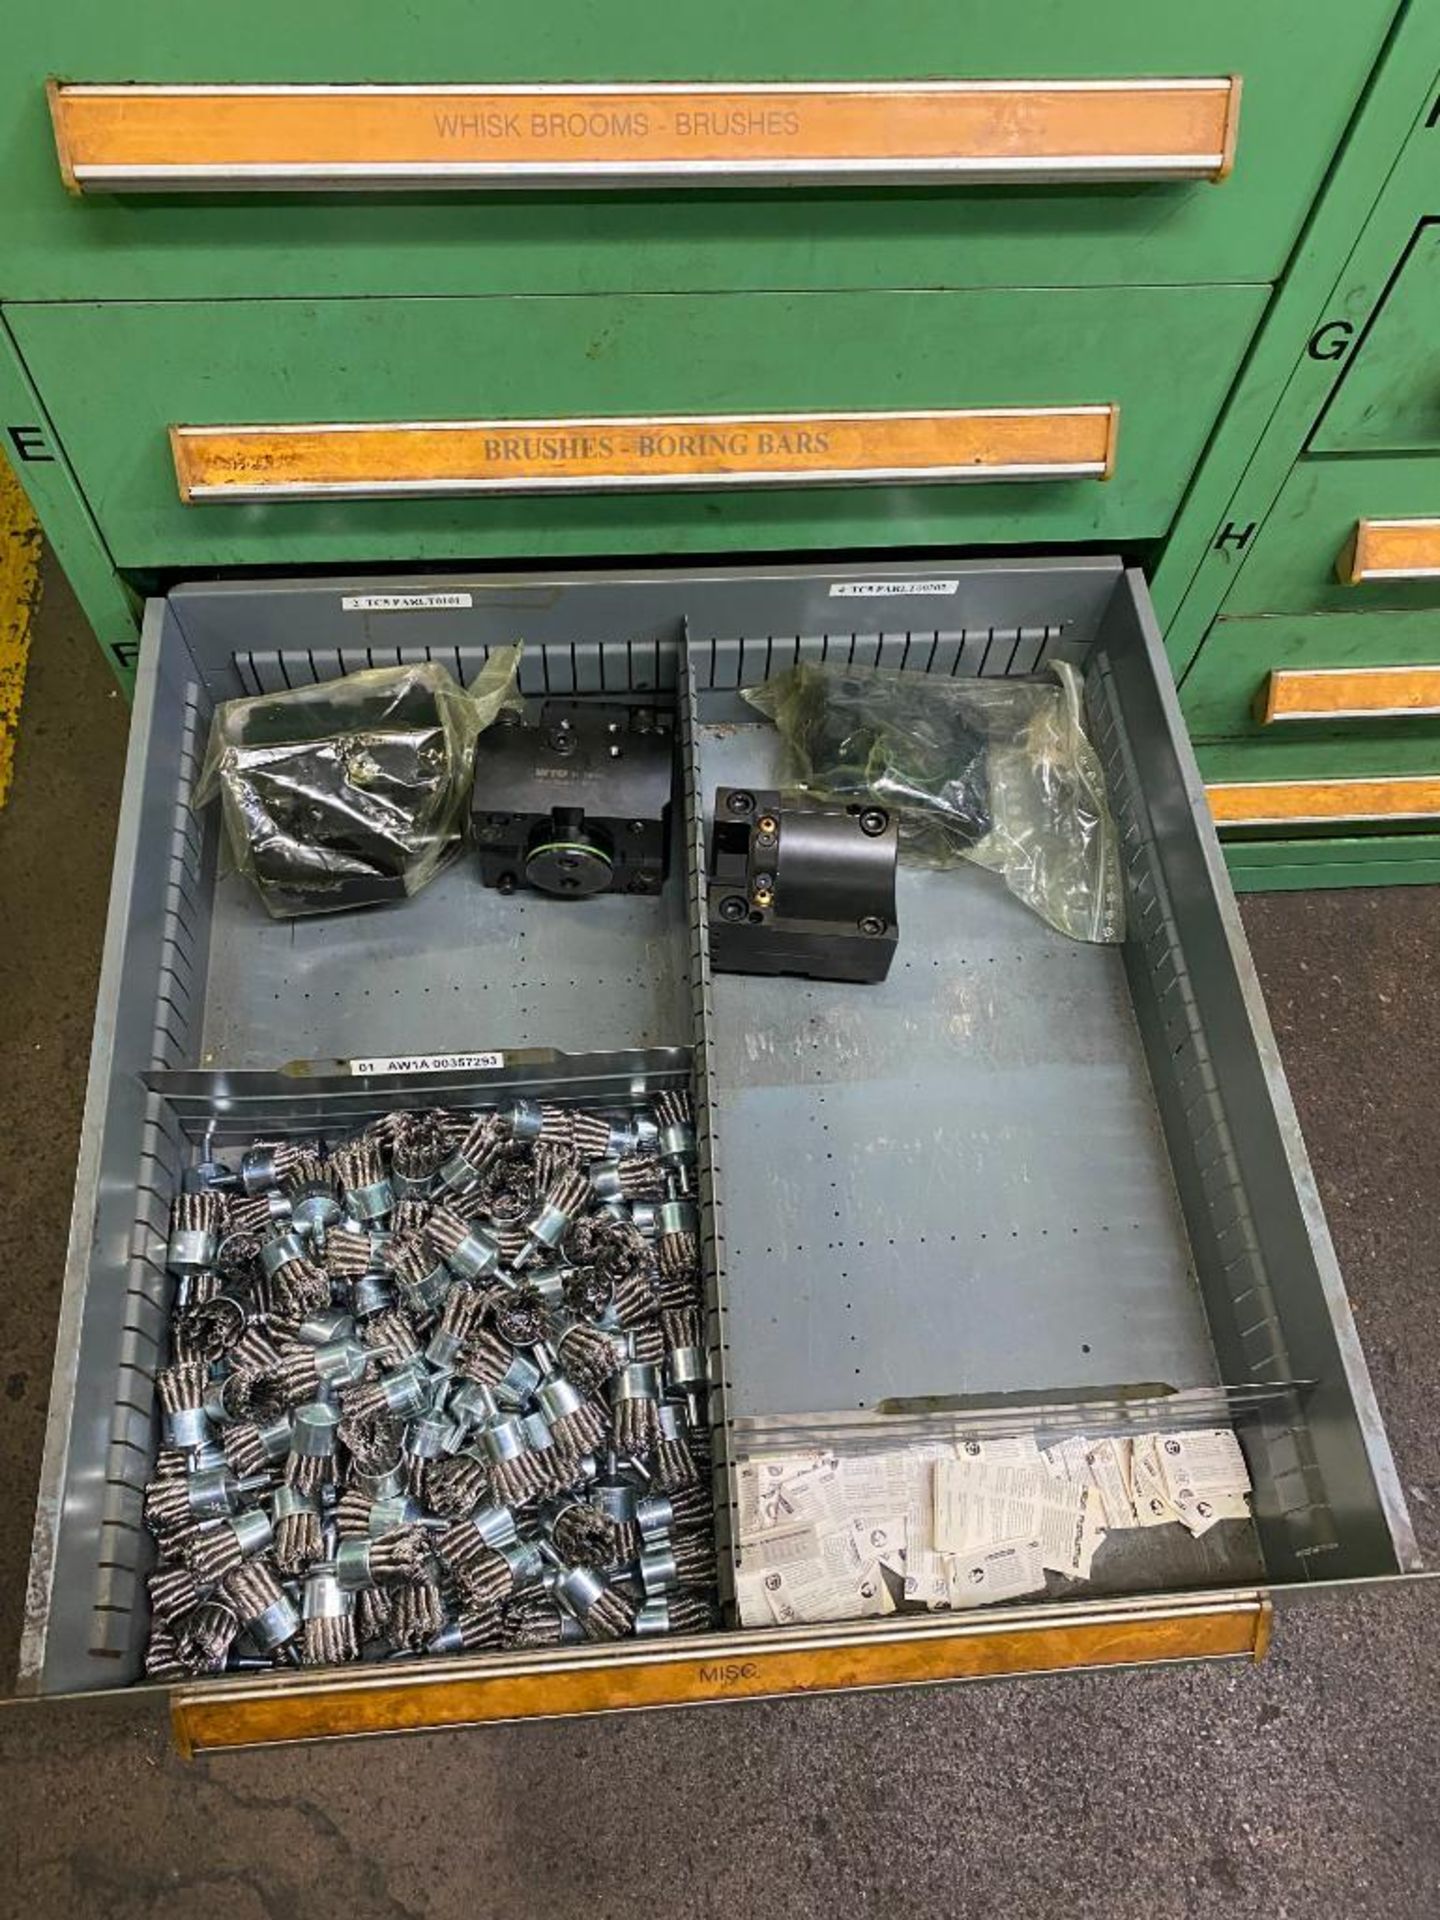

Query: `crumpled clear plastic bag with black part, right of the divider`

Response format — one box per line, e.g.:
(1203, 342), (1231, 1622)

(745, 660), (1125, 943)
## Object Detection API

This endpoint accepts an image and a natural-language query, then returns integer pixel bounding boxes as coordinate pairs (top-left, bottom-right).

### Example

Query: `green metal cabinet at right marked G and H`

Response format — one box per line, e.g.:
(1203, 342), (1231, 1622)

(1156, 8), (1440, 887)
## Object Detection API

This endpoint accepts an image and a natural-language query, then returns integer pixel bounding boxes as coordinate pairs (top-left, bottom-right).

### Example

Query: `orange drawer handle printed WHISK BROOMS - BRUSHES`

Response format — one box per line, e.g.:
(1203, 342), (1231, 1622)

(48, 75), (1240, 194)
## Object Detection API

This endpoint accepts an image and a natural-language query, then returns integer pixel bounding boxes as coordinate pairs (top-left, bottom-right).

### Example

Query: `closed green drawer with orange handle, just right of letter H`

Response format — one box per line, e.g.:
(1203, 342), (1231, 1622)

(1225, 453), (1440, 614)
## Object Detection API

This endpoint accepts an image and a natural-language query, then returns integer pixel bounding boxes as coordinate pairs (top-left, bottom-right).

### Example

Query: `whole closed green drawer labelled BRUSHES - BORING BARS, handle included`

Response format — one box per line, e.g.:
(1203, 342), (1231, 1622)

(8, 288), (1263, 566)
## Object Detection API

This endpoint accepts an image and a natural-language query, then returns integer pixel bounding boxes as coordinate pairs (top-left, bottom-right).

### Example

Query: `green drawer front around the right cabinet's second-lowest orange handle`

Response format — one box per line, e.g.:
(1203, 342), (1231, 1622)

(1181, 611), (1440, 741)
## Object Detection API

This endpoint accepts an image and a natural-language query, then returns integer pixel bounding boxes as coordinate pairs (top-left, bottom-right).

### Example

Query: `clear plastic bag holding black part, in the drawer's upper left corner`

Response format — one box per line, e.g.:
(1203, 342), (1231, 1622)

(194, 647), (522, 920)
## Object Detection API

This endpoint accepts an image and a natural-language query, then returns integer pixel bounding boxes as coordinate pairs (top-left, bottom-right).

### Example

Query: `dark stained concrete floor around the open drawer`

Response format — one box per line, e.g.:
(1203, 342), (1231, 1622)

(0, 549), (1440, 1920)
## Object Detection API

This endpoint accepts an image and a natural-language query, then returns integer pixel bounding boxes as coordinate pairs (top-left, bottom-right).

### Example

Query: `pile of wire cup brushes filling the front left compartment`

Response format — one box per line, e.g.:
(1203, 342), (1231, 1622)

(144, 1092), (716, 1678)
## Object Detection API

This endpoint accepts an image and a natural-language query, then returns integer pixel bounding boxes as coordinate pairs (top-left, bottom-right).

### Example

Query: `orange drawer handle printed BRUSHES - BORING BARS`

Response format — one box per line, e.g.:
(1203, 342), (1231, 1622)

(171, 407), (1119, 501)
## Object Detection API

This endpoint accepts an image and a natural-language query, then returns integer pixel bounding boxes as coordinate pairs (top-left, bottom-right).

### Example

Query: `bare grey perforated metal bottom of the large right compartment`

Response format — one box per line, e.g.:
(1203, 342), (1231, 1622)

(699, 724), (1215, 1417)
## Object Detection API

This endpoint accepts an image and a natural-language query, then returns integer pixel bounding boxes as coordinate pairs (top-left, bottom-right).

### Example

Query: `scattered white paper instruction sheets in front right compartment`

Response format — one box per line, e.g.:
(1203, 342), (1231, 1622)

(737, 1427), (1250, 1626)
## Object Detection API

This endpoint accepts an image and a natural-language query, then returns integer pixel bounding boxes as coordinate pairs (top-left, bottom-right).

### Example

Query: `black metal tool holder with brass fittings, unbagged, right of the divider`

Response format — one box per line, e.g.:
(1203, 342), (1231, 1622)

(707, 787), (900, 983)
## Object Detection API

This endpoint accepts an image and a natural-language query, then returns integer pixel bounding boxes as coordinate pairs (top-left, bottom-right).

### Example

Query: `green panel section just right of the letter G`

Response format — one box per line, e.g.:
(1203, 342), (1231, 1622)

(1309, 219), (1440, 453)
